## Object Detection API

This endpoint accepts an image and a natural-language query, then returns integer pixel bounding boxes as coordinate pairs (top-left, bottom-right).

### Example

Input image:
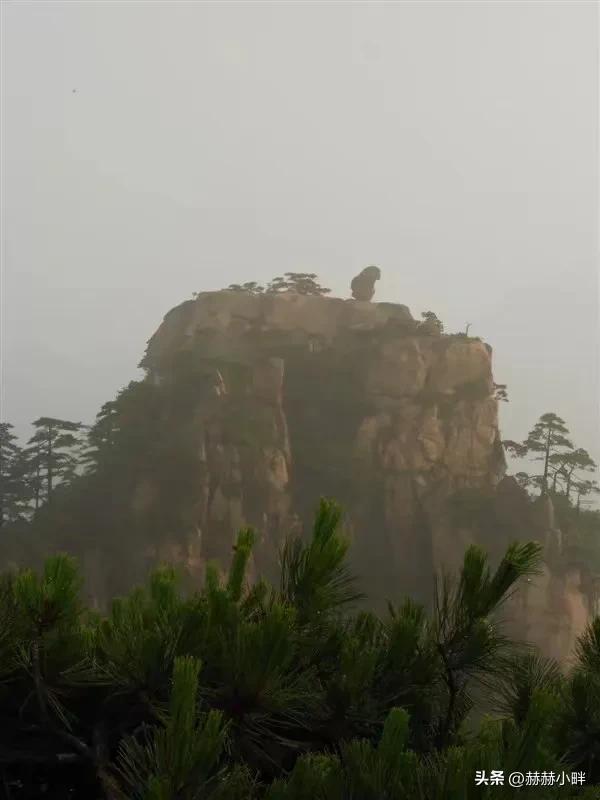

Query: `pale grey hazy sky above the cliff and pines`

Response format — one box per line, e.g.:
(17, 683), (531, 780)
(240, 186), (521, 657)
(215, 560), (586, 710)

(2, 0), (600, 472)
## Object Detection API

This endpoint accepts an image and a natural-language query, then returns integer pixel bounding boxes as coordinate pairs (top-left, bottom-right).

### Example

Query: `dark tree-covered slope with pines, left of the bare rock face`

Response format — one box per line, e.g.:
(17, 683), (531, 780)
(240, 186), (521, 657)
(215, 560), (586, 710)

(0, 376), (216, 576)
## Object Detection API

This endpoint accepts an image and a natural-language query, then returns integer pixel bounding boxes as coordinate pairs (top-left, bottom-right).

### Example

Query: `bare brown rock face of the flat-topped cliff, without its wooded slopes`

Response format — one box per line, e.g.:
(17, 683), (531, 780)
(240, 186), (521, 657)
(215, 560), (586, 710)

(133, 291), (505, 596)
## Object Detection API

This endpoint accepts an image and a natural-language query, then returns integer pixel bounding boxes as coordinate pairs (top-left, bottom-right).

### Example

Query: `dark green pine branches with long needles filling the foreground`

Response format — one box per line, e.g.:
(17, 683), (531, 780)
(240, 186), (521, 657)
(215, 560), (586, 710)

(0, 500), (600, 800)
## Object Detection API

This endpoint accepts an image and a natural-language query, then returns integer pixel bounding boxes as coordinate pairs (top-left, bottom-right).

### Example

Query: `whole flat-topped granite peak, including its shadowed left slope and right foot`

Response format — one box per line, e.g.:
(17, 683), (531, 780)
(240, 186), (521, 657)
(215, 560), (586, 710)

(5, 291), (598, 658)
